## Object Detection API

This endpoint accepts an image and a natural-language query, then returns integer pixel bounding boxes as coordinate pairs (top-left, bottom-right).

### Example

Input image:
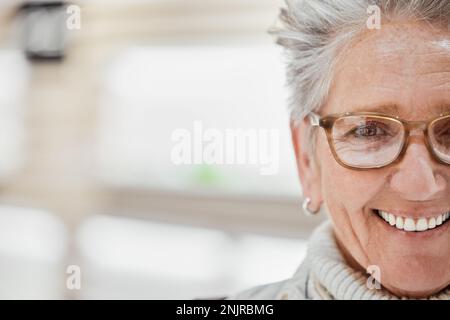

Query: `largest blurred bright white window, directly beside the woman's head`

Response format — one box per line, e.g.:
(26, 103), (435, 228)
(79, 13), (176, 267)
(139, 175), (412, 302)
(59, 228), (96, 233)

(96, 45), (299, 196)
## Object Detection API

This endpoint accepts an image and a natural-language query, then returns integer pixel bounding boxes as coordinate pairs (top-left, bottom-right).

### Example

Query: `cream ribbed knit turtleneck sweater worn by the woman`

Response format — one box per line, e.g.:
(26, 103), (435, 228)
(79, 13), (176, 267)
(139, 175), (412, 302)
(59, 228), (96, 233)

(230, 222), (450, 300)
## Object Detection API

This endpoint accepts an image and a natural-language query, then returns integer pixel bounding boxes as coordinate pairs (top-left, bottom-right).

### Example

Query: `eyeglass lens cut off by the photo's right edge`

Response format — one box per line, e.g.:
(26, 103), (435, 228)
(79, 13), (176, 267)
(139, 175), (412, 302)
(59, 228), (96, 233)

(430, 116), (450, 164)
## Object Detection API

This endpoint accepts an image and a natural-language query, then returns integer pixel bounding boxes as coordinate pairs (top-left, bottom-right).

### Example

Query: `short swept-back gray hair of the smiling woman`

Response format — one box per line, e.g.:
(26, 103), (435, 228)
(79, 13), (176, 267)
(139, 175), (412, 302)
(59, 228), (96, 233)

(270, 0), (450, 121)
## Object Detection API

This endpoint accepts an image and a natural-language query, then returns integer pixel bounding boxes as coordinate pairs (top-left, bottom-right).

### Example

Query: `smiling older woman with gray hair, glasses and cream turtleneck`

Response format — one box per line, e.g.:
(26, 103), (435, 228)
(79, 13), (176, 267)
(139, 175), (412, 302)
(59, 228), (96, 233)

(233, 0), (450, 299)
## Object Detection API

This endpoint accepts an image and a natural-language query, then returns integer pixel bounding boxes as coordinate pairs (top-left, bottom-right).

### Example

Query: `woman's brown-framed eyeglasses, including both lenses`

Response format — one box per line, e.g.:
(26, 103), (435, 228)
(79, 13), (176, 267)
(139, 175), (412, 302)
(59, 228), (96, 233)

(309, 112), (450, 170)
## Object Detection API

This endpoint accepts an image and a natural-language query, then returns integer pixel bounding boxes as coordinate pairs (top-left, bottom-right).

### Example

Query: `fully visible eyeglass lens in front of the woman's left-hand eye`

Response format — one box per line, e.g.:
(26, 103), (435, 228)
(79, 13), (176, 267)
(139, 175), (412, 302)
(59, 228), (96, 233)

(332, 115), (405, 168)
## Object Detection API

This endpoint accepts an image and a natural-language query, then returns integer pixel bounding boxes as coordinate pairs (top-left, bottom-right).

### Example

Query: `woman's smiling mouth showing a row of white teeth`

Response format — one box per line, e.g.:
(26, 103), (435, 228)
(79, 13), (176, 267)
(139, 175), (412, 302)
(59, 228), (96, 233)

(373, 209), (450, 232)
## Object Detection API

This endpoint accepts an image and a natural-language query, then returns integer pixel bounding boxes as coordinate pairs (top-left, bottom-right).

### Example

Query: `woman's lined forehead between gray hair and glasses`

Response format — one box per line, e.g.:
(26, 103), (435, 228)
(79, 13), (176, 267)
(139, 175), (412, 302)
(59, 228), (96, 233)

(323, 23), (450, 119)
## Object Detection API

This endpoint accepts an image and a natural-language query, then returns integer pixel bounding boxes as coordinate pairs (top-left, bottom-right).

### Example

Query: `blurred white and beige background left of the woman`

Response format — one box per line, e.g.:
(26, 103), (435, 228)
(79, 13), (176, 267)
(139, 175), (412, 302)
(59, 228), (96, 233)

(0, 0), (321, 299)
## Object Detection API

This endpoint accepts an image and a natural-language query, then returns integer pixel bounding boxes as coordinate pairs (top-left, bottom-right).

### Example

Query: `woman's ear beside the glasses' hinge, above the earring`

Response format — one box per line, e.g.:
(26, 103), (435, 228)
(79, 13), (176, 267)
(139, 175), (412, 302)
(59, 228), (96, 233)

(291, 119), (323, 210)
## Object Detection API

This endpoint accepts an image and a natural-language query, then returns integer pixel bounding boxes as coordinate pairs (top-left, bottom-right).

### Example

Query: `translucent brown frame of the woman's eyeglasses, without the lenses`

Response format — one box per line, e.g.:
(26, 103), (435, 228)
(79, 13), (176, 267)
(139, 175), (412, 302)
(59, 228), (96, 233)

(308, 112), (450, 171)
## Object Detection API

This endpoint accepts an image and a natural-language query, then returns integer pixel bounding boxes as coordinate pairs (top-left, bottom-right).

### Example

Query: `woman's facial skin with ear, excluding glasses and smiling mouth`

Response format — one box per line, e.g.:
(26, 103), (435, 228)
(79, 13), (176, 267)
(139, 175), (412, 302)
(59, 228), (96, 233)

(293, 23), (450, 297)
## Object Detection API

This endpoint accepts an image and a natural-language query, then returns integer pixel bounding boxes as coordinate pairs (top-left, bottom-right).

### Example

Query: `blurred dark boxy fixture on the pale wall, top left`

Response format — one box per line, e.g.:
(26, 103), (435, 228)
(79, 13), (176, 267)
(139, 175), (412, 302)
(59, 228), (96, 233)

(18, 1), (69, 61)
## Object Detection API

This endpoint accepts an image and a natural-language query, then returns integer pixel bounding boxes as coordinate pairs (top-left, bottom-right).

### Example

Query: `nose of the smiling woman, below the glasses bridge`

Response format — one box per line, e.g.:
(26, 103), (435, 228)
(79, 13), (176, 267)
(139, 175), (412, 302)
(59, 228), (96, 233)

(390, 143), (447, 201)
